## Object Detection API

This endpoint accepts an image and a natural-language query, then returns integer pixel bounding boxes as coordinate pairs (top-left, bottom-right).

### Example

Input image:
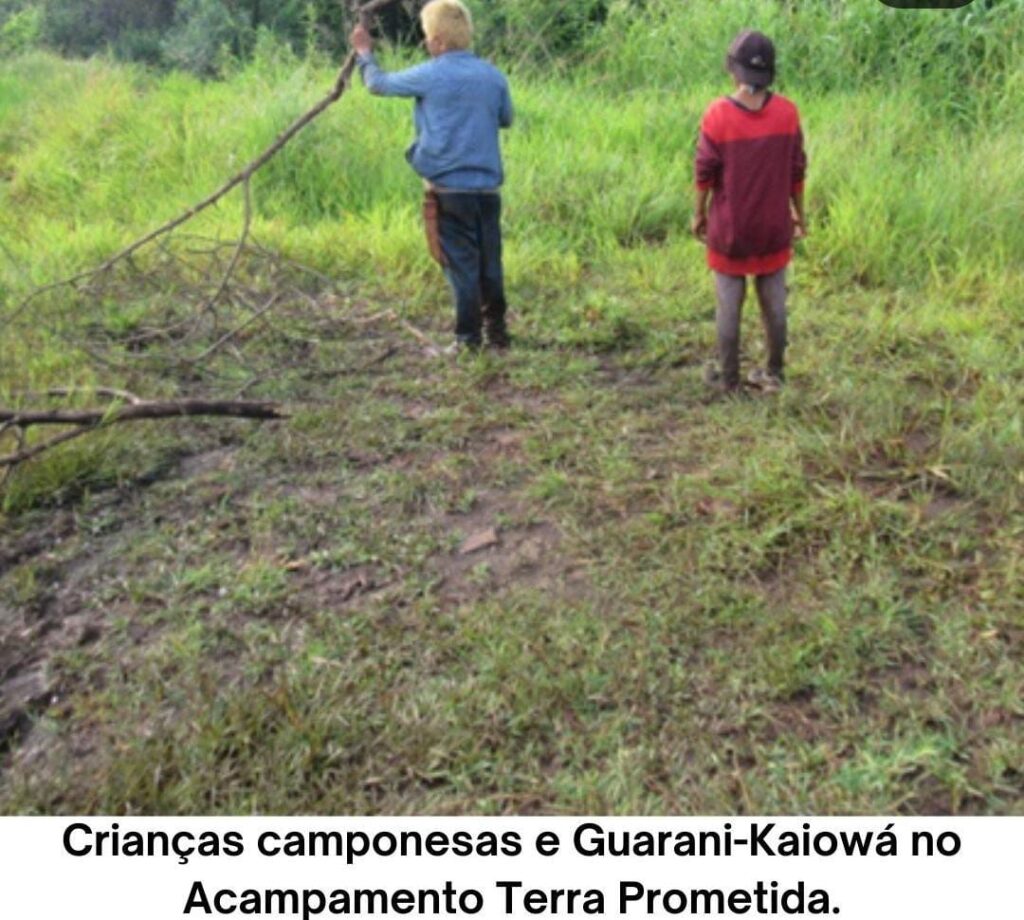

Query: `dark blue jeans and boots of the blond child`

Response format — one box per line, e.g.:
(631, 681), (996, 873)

(437, 192), (508, 346)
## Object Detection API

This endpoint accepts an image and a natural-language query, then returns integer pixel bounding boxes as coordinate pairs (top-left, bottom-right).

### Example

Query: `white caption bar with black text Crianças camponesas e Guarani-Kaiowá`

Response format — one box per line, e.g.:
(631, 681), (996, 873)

(0, 818), (1024, 920)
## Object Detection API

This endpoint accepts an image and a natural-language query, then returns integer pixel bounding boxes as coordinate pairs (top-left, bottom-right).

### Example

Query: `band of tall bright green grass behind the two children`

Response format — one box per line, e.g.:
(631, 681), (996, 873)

(6, 16), (1024, 299)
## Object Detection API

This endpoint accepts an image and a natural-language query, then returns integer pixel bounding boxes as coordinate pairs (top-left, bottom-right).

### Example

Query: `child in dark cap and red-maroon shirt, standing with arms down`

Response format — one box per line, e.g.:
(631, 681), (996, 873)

(691, 31), (807, 391)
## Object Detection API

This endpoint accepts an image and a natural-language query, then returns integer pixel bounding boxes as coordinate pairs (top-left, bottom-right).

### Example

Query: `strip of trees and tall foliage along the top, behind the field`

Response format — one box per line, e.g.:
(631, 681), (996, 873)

(0, 0), (1024, 87)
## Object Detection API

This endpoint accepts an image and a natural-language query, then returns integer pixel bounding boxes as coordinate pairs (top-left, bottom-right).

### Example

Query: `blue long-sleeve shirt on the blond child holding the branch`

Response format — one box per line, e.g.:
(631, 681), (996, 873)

(358, 51), (512, 192)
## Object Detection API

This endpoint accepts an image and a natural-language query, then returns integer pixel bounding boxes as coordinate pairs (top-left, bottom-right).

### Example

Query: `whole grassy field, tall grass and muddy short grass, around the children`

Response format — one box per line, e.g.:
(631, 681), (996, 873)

(0, 0), (1024, 813)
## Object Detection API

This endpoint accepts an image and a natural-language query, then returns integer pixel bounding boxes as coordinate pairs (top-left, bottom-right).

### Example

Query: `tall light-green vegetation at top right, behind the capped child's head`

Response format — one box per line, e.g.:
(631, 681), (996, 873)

(589, 0), (1024, 102)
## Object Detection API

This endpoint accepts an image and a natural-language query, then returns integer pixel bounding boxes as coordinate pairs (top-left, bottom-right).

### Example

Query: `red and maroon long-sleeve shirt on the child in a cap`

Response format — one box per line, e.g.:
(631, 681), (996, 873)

(696, 95), (807, 275)
